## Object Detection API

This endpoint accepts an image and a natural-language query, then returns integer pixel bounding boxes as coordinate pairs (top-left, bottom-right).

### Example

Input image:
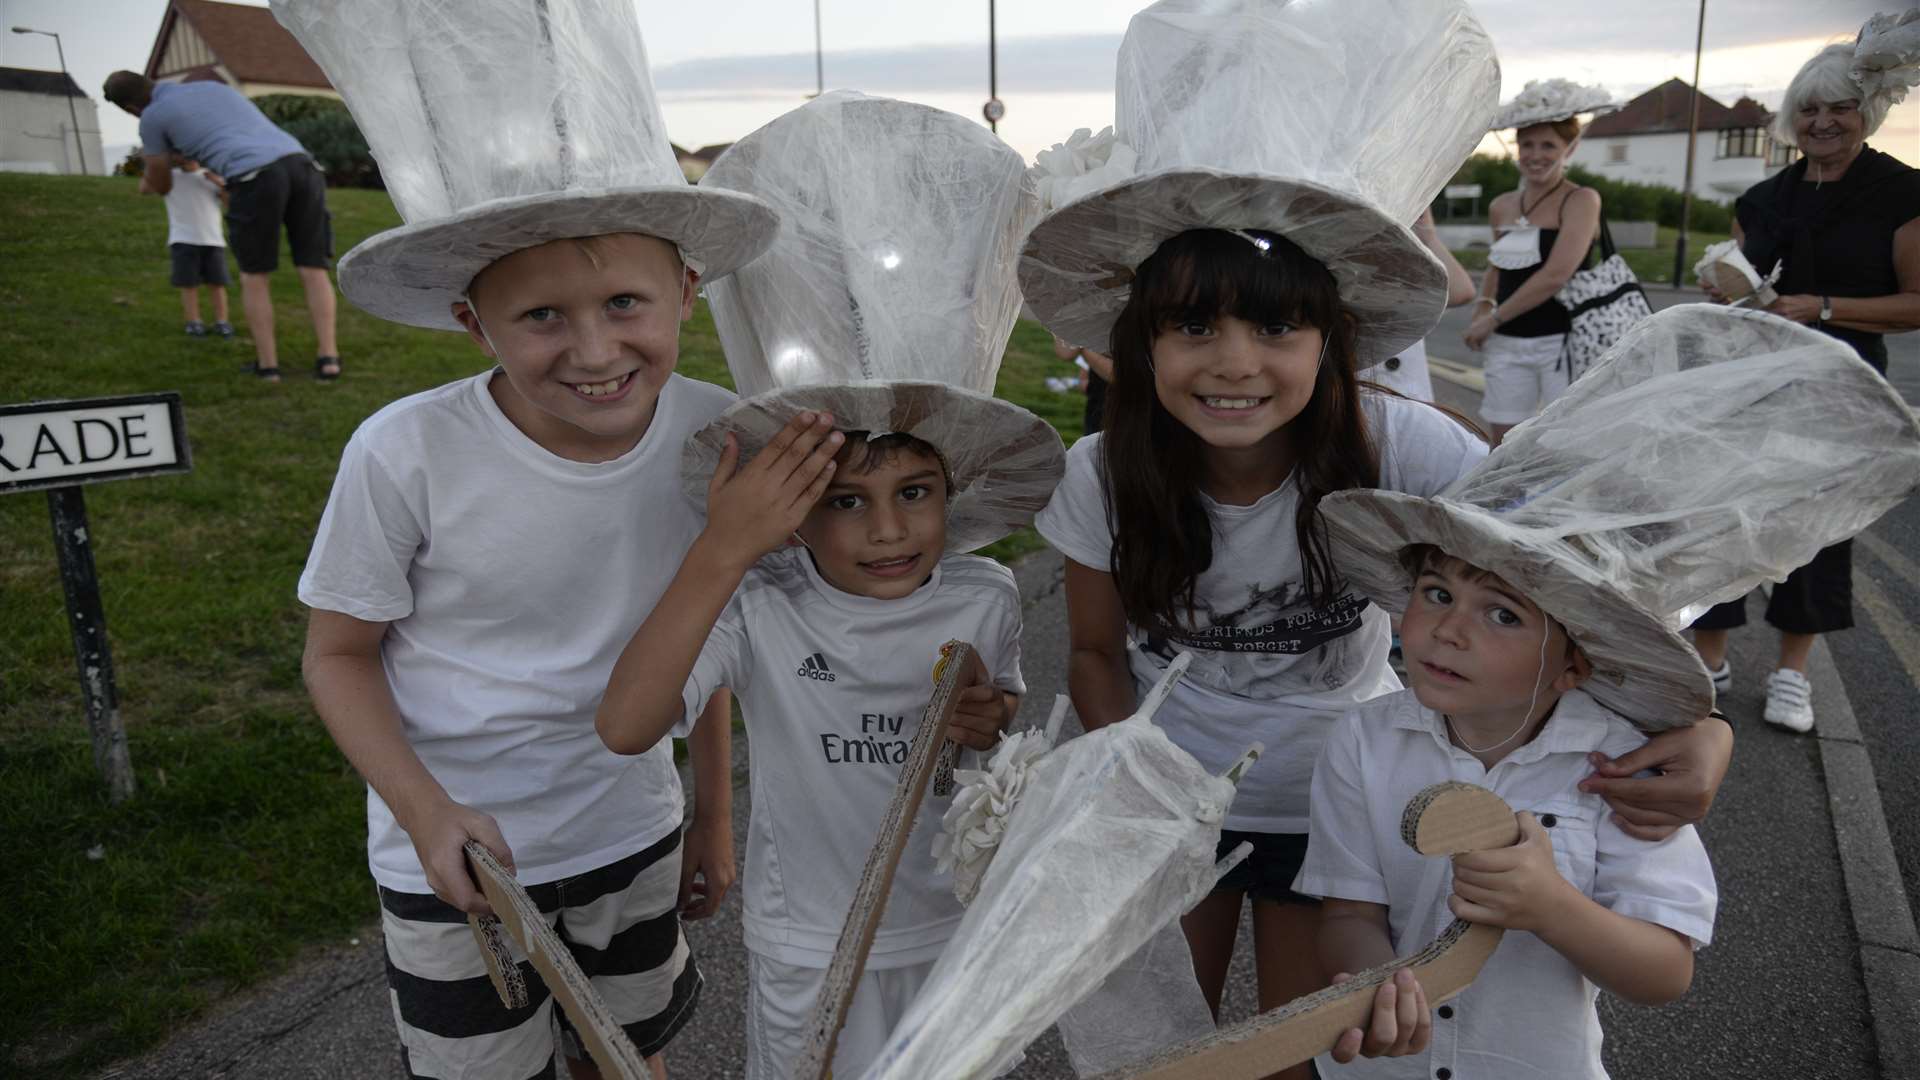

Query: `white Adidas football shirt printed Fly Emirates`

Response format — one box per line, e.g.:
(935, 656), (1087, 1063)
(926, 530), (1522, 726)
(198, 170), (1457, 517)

(685, 550), (1027, 969)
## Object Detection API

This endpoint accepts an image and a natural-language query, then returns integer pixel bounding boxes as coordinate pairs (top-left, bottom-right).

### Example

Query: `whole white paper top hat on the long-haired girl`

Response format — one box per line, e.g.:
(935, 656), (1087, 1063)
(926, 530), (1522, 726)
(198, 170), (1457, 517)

(1020, 0), (1500, 367)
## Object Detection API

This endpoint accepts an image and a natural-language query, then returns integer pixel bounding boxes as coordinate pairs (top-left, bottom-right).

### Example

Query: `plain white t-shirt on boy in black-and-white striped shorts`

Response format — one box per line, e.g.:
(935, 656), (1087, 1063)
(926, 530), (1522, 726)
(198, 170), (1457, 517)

(300, 373), (733, 892)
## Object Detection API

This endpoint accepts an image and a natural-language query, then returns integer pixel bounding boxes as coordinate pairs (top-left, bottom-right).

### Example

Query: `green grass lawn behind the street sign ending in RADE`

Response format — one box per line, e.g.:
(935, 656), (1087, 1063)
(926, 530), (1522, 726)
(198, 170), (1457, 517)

(0, 173), (1081, 1076)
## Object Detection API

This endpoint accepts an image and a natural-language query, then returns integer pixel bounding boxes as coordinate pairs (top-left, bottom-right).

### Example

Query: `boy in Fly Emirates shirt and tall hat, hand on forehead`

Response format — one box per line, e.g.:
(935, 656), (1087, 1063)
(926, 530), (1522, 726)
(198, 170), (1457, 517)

(595, 92), (1062, 1080)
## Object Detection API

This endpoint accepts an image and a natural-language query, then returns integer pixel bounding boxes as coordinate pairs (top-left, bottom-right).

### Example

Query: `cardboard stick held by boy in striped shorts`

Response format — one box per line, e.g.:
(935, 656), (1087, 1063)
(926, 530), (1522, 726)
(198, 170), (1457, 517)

(467, 840), (653, 1080)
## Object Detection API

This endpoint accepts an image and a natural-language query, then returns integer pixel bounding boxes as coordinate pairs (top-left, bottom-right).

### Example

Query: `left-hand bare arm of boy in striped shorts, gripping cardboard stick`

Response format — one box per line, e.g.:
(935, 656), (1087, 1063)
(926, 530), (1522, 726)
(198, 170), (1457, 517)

(300, 607), (513, 915)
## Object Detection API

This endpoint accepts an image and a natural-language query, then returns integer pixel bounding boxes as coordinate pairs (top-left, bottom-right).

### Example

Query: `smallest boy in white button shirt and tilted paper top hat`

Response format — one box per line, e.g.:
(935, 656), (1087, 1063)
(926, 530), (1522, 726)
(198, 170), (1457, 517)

(1294, 306), (1920, 1080)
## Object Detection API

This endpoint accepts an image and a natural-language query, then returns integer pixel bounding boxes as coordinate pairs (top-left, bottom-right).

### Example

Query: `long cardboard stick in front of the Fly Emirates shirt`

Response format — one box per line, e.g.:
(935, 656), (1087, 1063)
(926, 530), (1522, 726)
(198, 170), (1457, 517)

(793, 642), (973, 1080)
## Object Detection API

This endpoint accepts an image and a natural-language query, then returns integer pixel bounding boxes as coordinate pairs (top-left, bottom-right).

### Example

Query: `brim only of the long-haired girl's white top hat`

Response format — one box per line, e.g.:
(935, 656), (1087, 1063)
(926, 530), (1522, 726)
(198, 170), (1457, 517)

(1020, 167), (1446, 369)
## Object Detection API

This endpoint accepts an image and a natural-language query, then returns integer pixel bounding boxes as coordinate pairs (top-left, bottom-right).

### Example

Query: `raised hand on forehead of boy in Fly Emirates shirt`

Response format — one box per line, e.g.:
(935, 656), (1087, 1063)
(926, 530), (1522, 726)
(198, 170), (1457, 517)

(701, 413), (847, 573)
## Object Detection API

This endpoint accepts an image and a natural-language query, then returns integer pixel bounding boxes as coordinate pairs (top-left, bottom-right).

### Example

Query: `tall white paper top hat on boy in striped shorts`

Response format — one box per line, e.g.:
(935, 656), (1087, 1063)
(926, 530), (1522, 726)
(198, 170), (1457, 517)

(273, 0), (774, 331)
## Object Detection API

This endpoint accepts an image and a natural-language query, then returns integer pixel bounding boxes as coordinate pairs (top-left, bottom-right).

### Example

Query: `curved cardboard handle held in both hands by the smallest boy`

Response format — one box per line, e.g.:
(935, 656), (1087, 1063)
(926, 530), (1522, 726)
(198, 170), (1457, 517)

(1100, 780), (1521, 1080)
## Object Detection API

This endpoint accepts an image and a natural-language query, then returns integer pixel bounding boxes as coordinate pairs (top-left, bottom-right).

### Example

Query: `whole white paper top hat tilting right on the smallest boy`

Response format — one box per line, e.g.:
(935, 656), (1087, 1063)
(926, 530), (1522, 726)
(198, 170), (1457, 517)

(1319, 304), (1920, 730)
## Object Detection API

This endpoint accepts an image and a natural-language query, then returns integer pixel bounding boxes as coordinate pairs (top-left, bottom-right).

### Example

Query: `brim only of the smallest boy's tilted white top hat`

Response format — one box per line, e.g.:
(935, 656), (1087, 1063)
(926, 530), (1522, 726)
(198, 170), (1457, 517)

(1319, 490), (1713, 732)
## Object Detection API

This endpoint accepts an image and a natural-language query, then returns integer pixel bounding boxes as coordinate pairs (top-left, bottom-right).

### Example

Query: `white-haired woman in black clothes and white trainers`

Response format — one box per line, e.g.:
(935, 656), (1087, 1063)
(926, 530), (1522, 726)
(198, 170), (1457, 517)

(1693, 18), (1920, 732)
